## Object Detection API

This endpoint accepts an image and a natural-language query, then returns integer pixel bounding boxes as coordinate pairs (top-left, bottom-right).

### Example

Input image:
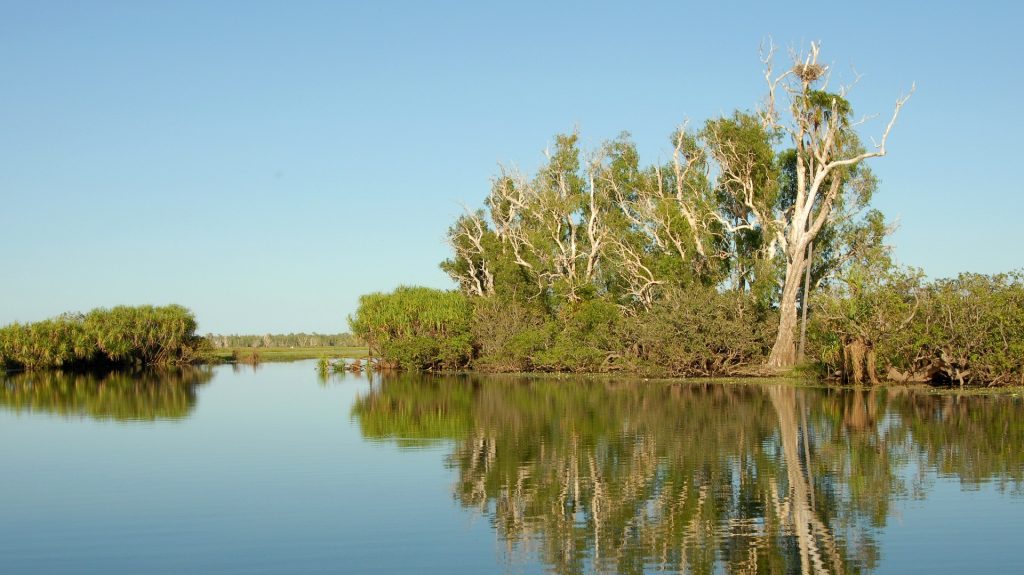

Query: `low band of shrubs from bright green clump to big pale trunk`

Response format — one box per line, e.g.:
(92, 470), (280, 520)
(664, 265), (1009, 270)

(350, 288), (771, 375)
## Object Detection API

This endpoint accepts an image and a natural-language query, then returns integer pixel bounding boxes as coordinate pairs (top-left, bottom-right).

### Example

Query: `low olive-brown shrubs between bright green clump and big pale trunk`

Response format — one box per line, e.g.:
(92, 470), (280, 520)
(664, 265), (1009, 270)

(472, 285), (776, 377)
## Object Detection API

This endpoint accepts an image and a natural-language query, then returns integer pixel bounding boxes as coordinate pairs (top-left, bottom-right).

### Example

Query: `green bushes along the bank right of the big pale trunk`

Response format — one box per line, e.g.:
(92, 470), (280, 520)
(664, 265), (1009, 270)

(811, 262), (1024, 385)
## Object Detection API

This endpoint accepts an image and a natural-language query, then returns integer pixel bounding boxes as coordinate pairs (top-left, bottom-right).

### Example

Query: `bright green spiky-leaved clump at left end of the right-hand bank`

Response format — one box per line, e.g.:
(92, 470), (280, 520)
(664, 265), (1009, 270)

(348, 286), (472, 370)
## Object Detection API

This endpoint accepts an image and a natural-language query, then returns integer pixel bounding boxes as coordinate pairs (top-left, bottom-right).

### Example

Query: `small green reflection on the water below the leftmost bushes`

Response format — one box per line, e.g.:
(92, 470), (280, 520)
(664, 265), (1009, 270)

(0, 367), (213, 422)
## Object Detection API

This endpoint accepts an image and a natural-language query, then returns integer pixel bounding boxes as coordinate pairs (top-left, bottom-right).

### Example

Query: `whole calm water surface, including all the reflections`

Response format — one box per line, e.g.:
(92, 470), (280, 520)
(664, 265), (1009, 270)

(0, 362), (1024, 574)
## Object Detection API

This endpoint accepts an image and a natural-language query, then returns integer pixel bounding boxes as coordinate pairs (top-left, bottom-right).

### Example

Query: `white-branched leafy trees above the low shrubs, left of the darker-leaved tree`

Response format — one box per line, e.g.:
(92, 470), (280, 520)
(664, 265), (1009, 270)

(441, 129), (729, 310)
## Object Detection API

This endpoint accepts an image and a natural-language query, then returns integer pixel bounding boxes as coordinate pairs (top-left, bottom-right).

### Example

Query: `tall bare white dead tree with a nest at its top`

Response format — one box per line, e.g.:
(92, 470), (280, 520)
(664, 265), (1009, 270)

(761, 43), (913, 367)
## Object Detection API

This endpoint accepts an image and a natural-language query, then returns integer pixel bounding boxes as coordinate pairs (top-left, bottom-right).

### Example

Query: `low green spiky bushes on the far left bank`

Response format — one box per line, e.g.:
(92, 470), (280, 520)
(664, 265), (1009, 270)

(0, 305), (209, 370)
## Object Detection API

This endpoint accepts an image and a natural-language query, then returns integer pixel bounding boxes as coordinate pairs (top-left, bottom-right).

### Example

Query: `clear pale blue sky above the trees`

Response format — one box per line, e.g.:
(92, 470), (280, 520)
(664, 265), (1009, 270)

(0, 0), (1024, 334)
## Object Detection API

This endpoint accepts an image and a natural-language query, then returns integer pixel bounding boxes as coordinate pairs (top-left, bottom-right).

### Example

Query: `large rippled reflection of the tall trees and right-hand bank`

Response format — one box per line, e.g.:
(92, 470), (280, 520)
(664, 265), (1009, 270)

(352, 377), (1024, 573)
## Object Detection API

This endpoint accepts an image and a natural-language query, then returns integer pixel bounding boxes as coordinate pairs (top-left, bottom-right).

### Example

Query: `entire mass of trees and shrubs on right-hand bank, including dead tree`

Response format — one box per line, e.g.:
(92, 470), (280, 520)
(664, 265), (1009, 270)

(351, 45), (1024, 385)
